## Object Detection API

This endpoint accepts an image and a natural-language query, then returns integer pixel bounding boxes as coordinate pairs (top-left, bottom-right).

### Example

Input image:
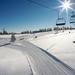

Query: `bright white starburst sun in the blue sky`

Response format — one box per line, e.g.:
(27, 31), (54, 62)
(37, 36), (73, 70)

(58, 0), (74, 13)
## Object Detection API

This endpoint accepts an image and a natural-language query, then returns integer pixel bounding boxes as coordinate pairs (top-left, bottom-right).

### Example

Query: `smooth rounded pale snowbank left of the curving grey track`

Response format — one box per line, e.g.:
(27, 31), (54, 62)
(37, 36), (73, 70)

(0, 47), (31, 75)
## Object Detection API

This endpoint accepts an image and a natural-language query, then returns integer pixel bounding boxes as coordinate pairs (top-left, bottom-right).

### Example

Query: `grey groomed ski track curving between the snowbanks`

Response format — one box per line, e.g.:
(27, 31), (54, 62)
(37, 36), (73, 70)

(6, 41), (75, 75)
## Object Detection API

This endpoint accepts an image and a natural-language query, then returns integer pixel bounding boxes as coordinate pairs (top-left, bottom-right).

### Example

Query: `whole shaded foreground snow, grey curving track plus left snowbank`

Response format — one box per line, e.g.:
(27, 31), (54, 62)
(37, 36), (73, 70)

(0, 40), (75, 75)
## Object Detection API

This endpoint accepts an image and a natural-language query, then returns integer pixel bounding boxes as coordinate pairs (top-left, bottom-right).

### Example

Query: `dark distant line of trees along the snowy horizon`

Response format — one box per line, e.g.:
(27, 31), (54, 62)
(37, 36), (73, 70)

(0, 27), (75, 35)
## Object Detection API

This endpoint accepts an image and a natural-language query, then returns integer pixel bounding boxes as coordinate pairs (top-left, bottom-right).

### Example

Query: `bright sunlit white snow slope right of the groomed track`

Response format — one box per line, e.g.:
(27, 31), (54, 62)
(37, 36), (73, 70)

(29, 30), (75, 69)
